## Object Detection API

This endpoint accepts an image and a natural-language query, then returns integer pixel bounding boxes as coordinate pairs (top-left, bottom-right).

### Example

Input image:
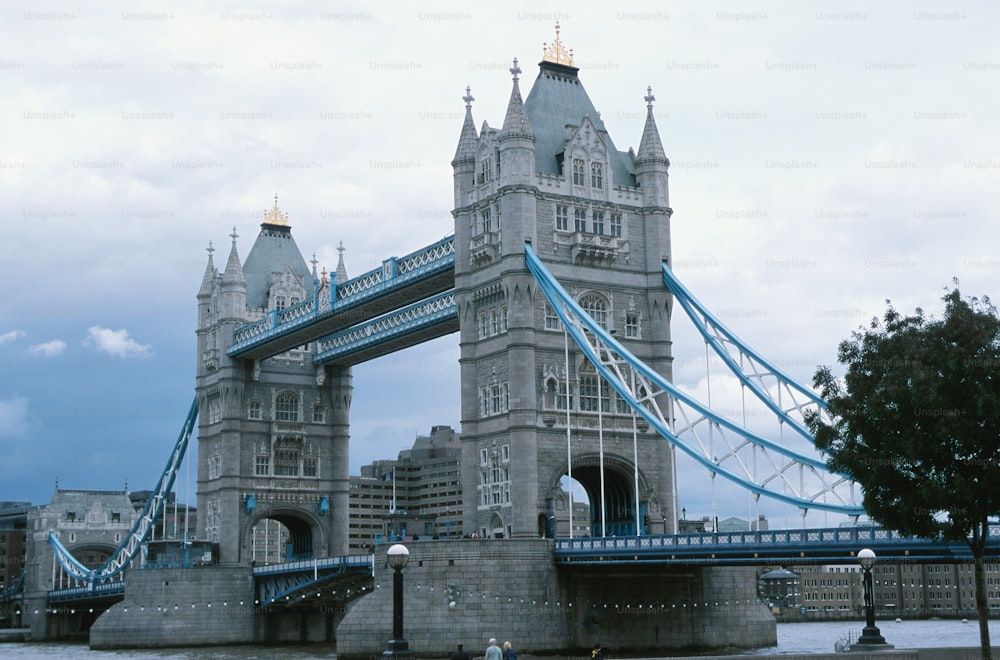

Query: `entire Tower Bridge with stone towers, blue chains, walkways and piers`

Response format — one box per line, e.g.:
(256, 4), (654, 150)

(17, 28), (984, 656)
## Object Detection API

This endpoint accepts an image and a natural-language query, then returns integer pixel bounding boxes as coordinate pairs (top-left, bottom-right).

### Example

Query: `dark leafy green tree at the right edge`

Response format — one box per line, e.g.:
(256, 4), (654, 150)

(808, 282), (1000, 660)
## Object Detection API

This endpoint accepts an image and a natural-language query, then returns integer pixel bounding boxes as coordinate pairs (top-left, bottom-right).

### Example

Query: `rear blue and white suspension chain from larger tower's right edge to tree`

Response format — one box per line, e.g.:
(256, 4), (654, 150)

(663, 263), (827, 442)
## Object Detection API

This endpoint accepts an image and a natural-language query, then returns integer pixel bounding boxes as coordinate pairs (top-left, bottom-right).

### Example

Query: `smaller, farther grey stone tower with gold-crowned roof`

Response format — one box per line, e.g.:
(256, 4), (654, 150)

(196, 196), (351, 564)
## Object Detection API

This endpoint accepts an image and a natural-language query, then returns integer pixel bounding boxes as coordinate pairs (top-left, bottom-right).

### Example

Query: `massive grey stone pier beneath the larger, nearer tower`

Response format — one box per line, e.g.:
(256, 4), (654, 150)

(336, 539), (777, 660)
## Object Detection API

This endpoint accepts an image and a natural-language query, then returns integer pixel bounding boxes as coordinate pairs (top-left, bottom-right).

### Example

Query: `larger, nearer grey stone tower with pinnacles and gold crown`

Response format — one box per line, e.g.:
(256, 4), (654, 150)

(452, 27), (676, 537)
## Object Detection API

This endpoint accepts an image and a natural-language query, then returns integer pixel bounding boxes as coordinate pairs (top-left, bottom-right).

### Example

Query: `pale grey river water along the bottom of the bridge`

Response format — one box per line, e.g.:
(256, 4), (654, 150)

(0, 619), (1000, 660)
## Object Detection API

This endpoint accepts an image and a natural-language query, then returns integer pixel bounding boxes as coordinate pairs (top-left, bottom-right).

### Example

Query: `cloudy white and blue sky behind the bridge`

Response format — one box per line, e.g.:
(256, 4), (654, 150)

(0, 0), (1000, 527)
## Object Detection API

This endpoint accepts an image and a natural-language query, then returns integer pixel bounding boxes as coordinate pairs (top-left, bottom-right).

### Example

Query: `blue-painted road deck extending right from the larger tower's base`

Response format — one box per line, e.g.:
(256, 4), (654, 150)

(554, 525), (1000, 565)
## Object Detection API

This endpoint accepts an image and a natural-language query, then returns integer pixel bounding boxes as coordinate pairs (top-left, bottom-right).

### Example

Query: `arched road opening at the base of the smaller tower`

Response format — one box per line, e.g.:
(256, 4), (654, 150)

(241, 507), (327, 564)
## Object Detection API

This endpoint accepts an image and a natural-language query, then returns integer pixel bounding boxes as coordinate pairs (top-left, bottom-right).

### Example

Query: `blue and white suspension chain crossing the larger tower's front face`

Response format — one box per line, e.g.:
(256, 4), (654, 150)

(525, 244), (864, 516)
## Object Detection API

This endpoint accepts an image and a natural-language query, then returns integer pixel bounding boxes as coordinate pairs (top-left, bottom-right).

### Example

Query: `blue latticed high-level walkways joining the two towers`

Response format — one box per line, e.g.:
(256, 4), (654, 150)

(226, 236), (458, 364)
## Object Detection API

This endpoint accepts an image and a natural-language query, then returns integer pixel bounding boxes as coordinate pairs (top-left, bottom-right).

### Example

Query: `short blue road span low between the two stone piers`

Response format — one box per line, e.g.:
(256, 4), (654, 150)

(253, 555), (375, 607)
